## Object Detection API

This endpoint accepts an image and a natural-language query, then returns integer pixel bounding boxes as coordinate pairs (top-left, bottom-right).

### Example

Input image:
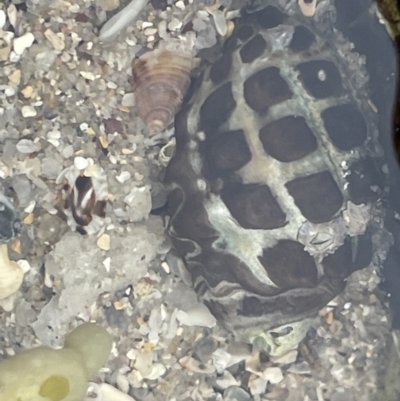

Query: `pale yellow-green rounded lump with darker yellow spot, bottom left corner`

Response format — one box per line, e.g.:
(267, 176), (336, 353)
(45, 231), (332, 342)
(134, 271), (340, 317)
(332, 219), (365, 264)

(0, 323), (112, 401)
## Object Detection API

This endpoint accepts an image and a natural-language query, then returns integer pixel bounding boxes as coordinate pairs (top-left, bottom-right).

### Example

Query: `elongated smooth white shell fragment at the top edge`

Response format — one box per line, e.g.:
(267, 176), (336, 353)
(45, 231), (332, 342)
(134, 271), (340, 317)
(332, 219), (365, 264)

(99, 0), (148, 42)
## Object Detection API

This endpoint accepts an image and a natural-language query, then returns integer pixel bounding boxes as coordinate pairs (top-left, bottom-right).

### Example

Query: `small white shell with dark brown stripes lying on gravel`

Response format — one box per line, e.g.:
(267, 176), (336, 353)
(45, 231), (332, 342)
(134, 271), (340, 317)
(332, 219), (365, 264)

(56, 163), (108, 235)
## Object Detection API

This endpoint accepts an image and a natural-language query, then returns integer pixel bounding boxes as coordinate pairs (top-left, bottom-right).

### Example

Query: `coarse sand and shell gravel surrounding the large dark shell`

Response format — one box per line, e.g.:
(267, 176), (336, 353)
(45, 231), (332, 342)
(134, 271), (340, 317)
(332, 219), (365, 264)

(0, 0), (389, 401)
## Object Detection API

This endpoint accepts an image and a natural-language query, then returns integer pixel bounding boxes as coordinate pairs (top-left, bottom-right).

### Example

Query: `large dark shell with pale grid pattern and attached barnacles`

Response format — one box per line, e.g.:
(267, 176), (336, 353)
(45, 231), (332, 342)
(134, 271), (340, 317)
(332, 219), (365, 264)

(166, 0), (387, 355)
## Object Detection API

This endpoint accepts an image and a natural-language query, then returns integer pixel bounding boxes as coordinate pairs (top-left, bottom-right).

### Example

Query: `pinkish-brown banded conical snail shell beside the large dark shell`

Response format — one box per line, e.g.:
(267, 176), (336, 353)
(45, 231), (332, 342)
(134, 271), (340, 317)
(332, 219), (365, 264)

(132, 39), (193, 134)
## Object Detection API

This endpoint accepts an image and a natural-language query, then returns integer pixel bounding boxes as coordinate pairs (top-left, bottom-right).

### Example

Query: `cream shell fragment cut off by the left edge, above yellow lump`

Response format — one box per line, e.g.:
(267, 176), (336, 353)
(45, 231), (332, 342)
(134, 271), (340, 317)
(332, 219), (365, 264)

(0, 244), (24, 300)
